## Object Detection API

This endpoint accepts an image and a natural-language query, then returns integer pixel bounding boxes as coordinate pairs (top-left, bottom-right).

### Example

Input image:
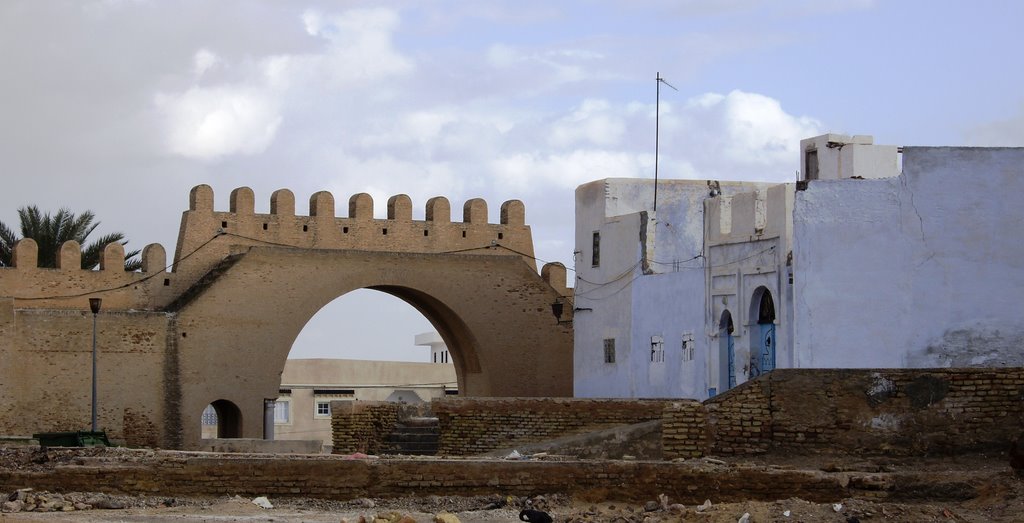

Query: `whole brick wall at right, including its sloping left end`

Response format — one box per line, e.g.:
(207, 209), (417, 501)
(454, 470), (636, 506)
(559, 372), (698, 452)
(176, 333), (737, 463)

(663, 368), (1024, 457)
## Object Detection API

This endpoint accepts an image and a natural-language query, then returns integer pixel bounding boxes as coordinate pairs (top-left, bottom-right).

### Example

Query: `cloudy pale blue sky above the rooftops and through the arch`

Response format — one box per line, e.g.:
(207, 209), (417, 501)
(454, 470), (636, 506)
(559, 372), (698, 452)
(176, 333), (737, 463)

(0, 0), (1024, 361)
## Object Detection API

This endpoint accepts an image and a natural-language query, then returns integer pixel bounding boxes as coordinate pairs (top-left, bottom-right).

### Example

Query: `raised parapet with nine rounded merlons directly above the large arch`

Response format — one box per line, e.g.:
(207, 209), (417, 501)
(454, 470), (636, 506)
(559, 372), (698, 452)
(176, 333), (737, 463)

(174, 185), (534, 270)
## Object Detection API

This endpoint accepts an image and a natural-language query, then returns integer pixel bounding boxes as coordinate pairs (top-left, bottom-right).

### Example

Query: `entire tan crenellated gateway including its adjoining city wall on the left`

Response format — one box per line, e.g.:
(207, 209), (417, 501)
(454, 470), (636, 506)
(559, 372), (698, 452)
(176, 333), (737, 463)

(0, 185), (572, 448)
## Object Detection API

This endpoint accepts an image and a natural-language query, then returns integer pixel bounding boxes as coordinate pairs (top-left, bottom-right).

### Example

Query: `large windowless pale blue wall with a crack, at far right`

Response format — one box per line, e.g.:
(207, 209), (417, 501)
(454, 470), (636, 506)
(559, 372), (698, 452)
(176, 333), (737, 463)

(794, 147), (1024, 367)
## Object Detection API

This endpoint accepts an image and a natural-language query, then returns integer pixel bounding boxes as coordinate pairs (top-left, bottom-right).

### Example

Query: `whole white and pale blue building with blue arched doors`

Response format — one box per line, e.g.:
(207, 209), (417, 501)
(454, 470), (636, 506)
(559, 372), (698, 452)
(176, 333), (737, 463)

(573, 134), (1024, 398)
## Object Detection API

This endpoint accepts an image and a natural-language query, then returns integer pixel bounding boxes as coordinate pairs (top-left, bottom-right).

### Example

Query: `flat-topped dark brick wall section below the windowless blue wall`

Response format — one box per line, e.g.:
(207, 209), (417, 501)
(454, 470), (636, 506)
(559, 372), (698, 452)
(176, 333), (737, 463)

(767, 367), (1024, 455)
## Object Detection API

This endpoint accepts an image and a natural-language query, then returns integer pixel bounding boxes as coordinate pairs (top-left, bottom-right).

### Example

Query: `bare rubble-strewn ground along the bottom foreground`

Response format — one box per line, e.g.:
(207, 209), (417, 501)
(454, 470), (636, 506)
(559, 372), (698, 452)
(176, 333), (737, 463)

(0, 449), (1024, 523)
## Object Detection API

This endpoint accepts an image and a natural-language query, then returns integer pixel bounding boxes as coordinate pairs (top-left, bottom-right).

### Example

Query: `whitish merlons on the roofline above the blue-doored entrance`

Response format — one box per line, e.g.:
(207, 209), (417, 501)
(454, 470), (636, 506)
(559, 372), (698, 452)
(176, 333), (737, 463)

(705, 183), (796, 246)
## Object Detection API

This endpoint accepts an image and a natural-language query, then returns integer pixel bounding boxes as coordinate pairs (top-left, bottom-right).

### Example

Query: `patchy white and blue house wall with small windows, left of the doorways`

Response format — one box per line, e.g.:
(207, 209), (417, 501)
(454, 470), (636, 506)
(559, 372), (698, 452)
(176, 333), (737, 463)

(573, 179), (751, 398)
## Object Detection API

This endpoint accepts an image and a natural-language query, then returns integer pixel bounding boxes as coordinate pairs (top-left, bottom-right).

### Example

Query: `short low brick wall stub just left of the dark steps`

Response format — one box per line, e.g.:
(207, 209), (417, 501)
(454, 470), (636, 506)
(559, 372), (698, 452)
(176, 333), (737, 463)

(331, 401), (401, 454)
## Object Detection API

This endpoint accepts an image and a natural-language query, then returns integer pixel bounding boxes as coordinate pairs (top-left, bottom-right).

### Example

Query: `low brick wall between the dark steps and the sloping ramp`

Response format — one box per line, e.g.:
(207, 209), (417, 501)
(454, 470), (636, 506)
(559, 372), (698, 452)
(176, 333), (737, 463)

(433, 398), (669, 455)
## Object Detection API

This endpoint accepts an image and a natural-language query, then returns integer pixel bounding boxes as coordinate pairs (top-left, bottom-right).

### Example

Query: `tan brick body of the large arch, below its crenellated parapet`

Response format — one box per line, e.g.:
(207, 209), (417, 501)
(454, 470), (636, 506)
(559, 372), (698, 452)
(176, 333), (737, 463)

(176, 247), (572, 445)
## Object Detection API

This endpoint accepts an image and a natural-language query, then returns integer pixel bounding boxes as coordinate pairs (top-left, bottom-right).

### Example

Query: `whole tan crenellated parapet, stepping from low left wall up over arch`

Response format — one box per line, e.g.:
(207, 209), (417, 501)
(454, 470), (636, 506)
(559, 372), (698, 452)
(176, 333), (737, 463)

(0, 185), (540, 310)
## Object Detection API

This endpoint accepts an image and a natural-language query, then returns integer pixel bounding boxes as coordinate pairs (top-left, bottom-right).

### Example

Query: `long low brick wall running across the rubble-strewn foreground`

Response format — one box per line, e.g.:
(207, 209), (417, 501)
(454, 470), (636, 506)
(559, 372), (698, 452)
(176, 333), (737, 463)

(0, 448), (872, 505)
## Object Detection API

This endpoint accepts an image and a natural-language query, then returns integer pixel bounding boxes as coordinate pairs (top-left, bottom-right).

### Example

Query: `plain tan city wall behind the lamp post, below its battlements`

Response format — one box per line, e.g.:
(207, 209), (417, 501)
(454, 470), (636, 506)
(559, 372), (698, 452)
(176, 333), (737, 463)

(0, 300), (169, 446)
